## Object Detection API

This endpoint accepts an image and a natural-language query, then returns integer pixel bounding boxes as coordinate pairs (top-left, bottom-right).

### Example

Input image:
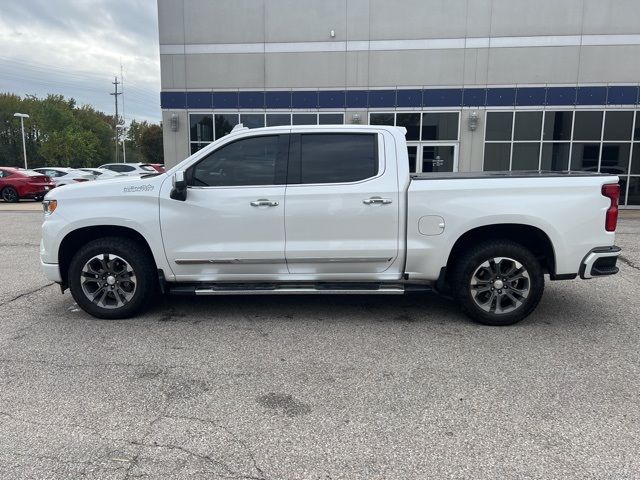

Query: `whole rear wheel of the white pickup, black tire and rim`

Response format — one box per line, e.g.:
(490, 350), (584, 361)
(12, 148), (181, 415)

(451, 240), (544, 326)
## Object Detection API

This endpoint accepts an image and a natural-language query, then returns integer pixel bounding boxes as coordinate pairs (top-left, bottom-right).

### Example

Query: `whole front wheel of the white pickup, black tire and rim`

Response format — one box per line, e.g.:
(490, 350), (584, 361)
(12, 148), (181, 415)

(67, 237), (157, 320)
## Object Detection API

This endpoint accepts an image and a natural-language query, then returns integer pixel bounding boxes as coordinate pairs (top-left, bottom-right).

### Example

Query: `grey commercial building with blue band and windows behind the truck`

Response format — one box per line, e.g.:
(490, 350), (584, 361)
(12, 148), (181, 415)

(158, 0), (640, 206)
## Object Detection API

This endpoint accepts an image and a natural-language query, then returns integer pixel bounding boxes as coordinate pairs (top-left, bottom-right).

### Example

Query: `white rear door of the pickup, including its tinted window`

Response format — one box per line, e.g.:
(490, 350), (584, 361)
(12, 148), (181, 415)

(285, 129), (400, 280)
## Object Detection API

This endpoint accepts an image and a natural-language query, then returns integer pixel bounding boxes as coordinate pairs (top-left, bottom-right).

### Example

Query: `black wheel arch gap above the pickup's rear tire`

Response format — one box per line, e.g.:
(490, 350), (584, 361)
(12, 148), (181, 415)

(446, 223), (556, 276)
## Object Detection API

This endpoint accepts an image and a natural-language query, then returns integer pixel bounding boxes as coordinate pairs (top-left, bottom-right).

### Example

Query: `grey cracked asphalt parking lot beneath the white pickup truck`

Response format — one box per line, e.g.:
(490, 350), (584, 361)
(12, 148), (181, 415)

(0, 204), (640, 479)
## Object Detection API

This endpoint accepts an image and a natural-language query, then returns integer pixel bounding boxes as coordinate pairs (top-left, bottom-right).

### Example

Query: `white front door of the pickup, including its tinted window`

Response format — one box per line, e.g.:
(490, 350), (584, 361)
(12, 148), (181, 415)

(160, 133), (289, 281)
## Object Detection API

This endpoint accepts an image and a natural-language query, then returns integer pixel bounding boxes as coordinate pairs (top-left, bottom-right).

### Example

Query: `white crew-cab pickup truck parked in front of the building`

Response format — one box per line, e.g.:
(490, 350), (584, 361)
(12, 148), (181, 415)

(40, 125), (620, 325)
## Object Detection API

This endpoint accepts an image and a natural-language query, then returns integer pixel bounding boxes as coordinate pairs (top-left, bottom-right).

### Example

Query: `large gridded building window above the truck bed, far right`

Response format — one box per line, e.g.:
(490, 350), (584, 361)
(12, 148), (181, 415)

(484, 110), (640, 205)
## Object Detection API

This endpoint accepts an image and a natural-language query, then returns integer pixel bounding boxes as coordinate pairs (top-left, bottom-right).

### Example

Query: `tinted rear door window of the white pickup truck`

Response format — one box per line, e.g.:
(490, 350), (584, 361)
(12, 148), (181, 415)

(300, 133), (378, 183)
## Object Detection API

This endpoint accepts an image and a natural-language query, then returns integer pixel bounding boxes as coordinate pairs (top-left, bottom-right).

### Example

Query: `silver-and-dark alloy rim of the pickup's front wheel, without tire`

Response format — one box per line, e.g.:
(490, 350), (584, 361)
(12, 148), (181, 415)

(80, 253), (136, 309)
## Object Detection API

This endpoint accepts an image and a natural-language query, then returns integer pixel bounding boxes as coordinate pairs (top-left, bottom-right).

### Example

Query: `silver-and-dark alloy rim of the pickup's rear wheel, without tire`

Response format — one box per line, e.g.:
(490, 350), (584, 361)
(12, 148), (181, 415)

(470, 257), (531, 315)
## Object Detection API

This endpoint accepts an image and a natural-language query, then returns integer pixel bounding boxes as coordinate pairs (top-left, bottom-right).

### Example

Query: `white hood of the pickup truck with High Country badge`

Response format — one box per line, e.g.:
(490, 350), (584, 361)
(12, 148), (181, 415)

(45, 173), (167, 201)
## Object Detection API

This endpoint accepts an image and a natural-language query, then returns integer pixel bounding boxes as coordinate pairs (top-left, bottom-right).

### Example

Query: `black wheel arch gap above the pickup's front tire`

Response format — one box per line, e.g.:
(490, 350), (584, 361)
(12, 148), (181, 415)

(58, 225), (156, 287)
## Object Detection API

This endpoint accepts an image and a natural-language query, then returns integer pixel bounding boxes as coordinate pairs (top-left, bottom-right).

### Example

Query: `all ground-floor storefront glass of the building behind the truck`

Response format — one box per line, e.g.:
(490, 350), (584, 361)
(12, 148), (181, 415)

(189, 109), (640, 206)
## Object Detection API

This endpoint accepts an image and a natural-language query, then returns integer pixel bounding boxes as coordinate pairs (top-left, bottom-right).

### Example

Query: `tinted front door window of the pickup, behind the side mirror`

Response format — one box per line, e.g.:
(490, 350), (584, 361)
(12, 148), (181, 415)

(187, 135), (278, 187)
